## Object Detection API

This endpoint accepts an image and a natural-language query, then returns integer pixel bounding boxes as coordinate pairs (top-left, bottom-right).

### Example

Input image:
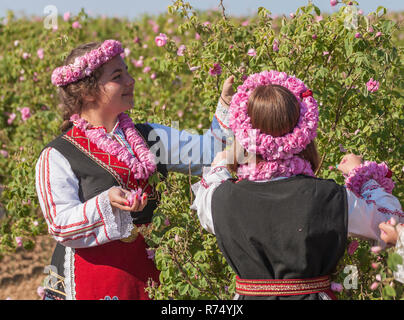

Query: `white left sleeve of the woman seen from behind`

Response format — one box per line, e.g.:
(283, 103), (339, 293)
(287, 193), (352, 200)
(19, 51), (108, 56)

(191, 160), (231, 234)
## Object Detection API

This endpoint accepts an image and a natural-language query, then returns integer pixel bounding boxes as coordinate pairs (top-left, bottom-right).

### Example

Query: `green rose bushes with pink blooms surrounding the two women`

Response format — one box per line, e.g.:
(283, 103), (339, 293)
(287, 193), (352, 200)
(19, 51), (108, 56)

(0, 1), (404, 299)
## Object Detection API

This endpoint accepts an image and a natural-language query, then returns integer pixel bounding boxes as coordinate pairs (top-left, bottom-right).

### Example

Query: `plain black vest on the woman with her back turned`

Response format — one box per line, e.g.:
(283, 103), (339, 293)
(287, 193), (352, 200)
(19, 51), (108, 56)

(212, 175), (348, 299)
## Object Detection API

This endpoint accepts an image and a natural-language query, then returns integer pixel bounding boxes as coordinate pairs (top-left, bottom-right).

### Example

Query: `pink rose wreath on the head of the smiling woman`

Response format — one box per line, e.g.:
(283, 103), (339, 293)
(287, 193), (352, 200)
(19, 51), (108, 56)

(51, 40), (124, 87)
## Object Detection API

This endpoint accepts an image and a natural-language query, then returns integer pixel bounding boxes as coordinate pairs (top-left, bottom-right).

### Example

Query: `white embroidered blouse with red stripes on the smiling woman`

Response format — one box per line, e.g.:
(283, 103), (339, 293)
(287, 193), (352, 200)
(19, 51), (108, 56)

(36, 103), (230, 248)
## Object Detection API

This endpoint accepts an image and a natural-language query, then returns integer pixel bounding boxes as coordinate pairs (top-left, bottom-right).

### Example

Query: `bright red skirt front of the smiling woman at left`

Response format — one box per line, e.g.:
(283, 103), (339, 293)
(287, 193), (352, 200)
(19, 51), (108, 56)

(72, 234), (159, 300)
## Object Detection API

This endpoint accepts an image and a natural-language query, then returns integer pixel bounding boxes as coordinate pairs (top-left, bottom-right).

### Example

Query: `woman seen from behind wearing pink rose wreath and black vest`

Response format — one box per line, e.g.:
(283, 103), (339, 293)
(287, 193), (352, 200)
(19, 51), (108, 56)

(191, 71), (404, 300)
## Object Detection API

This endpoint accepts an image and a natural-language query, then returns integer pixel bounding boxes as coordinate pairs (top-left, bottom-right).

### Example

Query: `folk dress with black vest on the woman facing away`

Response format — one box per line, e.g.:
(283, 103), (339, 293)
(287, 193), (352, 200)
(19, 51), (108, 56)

(191, 162), (404, 300)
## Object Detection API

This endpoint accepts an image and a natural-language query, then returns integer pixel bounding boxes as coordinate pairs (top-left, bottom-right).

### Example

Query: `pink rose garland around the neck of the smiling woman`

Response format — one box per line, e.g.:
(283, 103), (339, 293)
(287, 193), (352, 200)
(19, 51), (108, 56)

(70, 113), (156, 180)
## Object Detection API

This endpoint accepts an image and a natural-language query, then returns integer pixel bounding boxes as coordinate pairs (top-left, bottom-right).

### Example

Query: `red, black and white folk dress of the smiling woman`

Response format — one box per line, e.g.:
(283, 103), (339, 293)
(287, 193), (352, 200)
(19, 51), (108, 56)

(36, 103), (228, 300)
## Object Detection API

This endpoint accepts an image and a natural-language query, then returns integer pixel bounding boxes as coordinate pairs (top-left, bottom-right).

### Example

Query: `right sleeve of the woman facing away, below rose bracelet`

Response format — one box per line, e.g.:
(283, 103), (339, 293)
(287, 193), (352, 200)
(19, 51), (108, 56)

(347, 180), (404, 245)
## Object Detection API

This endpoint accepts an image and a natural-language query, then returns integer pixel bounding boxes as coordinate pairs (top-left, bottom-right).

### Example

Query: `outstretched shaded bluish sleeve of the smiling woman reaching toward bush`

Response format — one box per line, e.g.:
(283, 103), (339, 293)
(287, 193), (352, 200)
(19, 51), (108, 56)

(149, 103), (232, 175)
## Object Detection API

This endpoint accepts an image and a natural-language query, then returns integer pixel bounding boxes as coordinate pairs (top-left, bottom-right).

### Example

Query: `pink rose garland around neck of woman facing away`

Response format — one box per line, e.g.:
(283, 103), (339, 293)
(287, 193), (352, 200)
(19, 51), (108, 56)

(237, 156), (314, 181)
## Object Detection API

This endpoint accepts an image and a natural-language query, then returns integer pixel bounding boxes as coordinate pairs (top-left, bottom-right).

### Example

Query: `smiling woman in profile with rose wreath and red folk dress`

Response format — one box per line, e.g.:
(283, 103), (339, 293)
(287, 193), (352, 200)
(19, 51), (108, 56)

(36, 40), (231, 300)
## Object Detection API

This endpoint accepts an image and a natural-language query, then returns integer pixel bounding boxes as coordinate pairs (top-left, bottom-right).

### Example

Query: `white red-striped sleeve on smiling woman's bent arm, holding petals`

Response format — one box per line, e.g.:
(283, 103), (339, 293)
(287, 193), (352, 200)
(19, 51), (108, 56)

(36, 148), (133, 248)
